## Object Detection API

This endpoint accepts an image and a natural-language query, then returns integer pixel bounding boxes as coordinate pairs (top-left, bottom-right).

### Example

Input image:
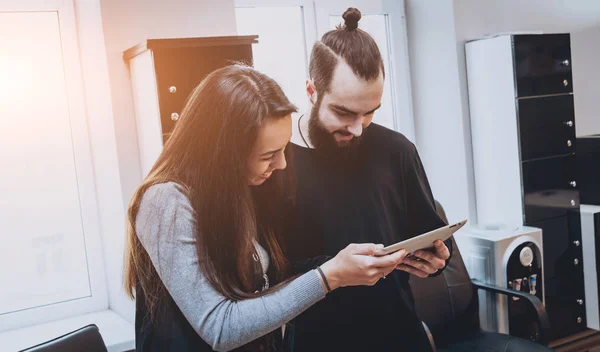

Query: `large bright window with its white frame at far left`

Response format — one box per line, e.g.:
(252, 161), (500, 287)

(0, 1), (107, 332)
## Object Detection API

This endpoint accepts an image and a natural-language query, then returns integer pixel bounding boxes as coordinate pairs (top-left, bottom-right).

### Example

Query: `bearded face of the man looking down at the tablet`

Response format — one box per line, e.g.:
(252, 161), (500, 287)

(307, 61), (383, 149)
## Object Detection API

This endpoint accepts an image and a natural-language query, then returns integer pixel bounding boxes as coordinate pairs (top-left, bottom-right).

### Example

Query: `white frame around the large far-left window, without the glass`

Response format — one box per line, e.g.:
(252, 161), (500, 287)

(0, 0), (108, 332)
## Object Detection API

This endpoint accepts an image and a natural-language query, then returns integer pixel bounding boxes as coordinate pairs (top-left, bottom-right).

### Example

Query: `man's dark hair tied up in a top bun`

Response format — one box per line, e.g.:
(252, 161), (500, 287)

(309, 7), (385, 93)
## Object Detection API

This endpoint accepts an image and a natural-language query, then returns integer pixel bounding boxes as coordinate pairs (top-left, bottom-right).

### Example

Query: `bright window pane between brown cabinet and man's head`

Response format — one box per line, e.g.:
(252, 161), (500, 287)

(235, 6), (308, 113)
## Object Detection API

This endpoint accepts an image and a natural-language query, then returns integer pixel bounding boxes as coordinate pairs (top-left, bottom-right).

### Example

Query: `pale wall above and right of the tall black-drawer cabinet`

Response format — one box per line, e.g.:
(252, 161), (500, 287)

(454, 0), (600, 139)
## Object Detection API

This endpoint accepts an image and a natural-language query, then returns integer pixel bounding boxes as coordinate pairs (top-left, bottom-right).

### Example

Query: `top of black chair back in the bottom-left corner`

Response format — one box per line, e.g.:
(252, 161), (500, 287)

(21, 324), (107, 352)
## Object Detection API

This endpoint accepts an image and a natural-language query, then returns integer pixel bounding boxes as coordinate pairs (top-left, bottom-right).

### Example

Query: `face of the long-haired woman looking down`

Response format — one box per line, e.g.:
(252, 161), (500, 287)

(248, 115), (292, 186)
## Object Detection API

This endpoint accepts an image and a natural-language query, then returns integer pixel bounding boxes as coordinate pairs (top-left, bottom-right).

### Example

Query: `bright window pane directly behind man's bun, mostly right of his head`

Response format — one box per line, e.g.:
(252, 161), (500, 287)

(329, 15), (398, 130)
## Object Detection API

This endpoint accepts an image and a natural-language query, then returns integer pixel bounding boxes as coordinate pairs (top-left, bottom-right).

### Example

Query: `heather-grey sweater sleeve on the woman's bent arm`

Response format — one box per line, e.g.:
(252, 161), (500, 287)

(136, 183), (325, 351)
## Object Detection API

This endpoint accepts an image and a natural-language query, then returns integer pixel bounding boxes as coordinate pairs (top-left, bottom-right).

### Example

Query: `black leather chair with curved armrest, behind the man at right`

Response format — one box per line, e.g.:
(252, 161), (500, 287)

(410, 202), (552, 352)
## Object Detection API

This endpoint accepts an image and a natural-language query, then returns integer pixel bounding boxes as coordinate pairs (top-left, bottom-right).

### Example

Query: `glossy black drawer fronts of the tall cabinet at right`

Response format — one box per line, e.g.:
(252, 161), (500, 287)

(513, 34), (586, 339)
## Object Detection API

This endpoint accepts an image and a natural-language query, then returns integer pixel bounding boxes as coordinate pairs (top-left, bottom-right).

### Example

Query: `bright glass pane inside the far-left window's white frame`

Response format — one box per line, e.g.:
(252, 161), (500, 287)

(0, 12), (90, 314)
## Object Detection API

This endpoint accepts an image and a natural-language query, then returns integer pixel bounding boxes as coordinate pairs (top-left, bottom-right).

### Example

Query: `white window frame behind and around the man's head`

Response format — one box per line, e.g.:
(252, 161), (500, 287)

(235, 0), (416, 143)
